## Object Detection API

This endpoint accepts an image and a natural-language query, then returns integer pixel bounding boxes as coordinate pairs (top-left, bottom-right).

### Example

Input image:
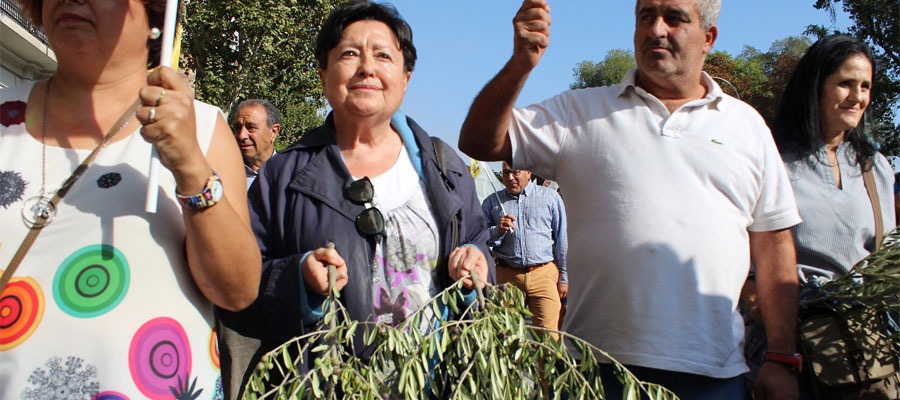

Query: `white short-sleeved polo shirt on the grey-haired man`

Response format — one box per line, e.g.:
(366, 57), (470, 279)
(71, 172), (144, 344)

(509, 70), (800, 378)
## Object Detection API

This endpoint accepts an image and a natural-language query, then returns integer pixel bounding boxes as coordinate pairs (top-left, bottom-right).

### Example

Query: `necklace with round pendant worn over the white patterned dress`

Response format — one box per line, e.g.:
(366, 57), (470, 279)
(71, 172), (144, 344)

(22, 77), (141, 229)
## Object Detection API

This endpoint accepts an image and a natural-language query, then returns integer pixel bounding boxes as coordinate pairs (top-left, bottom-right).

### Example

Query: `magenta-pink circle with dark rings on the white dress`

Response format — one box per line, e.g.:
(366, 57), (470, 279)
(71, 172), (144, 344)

(128, 317), (191, 398)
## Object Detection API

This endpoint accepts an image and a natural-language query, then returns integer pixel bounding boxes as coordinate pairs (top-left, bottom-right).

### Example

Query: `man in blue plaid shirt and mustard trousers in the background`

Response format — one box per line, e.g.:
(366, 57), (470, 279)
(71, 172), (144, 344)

(481, 163), (569, 337)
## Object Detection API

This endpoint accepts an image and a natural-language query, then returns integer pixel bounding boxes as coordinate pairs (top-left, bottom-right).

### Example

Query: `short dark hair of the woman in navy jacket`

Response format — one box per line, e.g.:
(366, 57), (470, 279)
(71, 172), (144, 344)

(315, 0), (416, 72)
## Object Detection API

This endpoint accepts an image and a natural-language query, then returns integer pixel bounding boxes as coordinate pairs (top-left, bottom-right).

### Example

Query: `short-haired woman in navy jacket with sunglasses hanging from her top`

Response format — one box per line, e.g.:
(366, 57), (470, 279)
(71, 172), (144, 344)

(222, 1), (493, 396)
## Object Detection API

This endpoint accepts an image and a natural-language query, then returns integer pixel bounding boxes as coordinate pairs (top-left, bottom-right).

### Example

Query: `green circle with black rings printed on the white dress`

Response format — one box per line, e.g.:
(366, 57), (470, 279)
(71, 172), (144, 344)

(53, 244), (131, 318)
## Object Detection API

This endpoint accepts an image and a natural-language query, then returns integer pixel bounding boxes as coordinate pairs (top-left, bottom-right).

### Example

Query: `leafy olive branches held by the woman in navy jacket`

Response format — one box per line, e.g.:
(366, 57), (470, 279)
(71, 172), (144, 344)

(244, 276), (677, 400)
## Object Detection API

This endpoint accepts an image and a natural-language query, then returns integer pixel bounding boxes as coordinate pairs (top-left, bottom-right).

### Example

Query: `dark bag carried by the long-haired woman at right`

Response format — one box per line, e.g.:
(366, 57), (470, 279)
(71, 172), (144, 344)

(799, 300), (900, 400)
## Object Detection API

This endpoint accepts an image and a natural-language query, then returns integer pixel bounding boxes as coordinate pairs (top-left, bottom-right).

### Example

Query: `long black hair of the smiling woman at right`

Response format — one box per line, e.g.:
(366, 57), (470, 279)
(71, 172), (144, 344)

(772, 35), (875, 166)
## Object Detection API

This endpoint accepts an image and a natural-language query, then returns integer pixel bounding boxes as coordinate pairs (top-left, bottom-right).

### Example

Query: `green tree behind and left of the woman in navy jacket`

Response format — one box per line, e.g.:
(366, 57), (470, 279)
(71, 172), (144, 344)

(182, 0), (338, 149)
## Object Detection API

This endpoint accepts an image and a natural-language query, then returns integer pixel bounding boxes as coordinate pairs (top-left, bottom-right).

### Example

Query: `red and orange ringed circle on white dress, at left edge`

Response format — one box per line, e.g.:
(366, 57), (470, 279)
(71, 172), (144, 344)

(0, 278), (45, 351)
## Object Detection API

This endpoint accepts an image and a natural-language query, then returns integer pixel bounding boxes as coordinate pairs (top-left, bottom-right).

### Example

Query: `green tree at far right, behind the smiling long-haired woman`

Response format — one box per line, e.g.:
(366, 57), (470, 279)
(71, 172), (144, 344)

(807, 0), (900, 156)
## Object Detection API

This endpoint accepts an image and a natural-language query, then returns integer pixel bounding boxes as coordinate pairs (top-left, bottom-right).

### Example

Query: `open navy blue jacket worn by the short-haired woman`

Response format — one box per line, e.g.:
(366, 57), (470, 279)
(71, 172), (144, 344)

(249, 115), (495, 344)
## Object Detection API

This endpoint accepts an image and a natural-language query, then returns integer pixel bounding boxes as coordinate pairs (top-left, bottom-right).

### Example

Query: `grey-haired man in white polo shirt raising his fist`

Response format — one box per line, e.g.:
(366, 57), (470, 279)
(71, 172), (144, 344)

(459, 0), (800, 399)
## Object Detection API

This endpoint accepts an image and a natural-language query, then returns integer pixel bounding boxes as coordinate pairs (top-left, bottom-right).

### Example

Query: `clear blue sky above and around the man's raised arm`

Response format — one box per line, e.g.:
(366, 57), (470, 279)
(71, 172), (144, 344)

(389, 0), (850, 153)
